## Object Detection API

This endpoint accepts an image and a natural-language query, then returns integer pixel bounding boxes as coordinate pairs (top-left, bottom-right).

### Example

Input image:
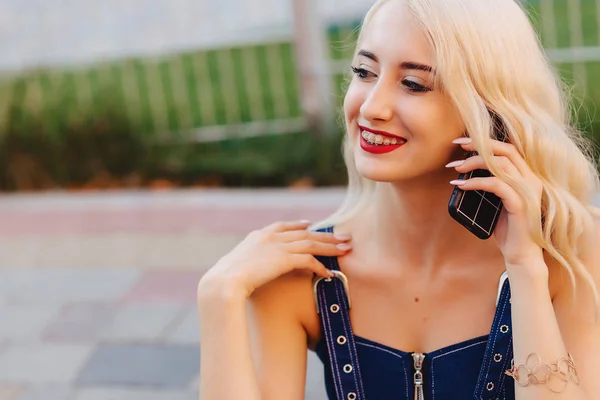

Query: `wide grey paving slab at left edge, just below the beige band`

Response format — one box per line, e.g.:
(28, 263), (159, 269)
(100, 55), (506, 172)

(0, 269), (140, 304)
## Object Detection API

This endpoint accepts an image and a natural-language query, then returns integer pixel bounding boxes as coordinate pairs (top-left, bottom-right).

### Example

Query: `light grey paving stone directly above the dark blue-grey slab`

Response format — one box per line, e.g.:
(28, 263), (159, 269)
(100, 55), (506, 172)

(101, 304), (181, 342)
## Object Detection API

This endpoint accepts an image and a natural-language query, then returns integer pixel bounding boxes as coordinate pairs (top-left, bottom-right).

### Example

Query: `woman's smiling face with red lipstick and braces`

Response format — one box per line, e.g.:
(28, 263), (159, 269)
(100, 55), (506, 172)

(344, 0), (464, 182)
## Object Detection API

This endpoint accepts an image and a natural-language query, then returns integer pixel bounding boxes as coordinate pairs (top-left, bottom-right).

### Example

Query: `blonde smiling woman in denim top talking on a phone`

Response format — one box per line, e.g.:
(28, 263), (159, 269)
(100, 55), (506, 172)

(198, 0), (600, 400)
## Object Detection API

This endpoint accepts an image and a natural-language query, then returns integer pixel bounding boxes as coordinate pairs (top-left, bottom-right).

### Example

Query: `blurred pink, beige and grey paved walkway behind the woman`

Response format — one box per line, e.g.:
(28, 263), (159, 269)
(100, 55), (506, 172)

(0, 190), (342, 400)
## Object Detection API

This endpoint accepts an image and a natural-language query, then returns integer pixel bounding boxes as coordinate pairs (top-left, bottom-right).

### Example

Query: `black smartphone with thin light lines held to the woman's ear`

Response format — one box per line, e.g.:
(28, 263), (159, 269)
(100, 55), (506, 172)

(448, 113), (507, 240)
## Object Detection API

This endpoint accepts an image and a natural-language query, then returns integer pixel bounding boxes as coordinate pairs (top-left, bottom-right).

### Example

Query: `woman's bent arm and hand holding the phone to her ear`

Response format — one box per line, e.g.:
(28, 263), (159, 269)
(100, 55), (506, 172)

(448, 138), (600, 400)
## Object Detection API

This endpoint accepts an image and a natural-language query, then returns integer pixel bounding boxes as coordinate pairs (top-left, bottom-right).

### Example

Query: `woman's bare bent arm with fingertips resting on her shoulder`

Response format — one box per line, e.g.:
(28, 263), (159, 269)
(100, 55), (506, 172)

(198, 222), (349, 400)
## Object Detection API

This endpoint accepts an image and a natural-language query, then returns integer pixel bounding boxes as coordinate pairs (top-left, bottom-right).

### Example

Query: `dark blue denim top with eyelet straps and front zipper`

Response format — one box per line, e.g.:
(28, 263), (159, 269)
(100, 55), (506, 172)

(314, 227), (515, 400)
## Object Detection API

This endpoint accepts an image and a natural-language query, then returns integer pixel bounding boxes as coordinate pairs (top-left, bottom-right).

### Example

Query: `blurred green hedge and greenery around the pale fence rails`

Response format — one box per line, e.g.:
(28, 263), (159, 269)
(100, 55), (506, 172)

(0, 9), (600, 190)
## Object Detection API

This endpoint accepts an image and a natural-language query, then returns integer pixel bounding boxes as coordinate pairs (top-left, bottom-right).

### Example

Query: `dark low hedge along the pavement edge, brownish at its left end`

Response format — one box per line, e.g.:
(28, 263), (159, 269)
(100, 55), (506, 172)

(0, 74), (345, 190)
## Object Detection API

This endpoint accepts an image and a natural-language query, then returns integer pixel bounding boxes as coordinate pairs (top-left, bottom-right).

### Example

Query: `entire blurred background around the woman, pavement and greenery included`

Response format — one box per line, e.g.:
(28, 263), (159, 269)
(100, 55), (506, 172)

(0, 0), (600, 400)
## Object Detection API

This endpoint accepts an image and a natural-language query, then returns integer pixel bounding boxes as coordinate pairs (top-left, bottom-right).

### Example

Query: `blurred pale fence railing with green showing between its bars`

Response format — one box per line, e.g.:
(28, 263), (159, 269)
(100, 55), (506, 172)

(0, 0), (600, 141)
